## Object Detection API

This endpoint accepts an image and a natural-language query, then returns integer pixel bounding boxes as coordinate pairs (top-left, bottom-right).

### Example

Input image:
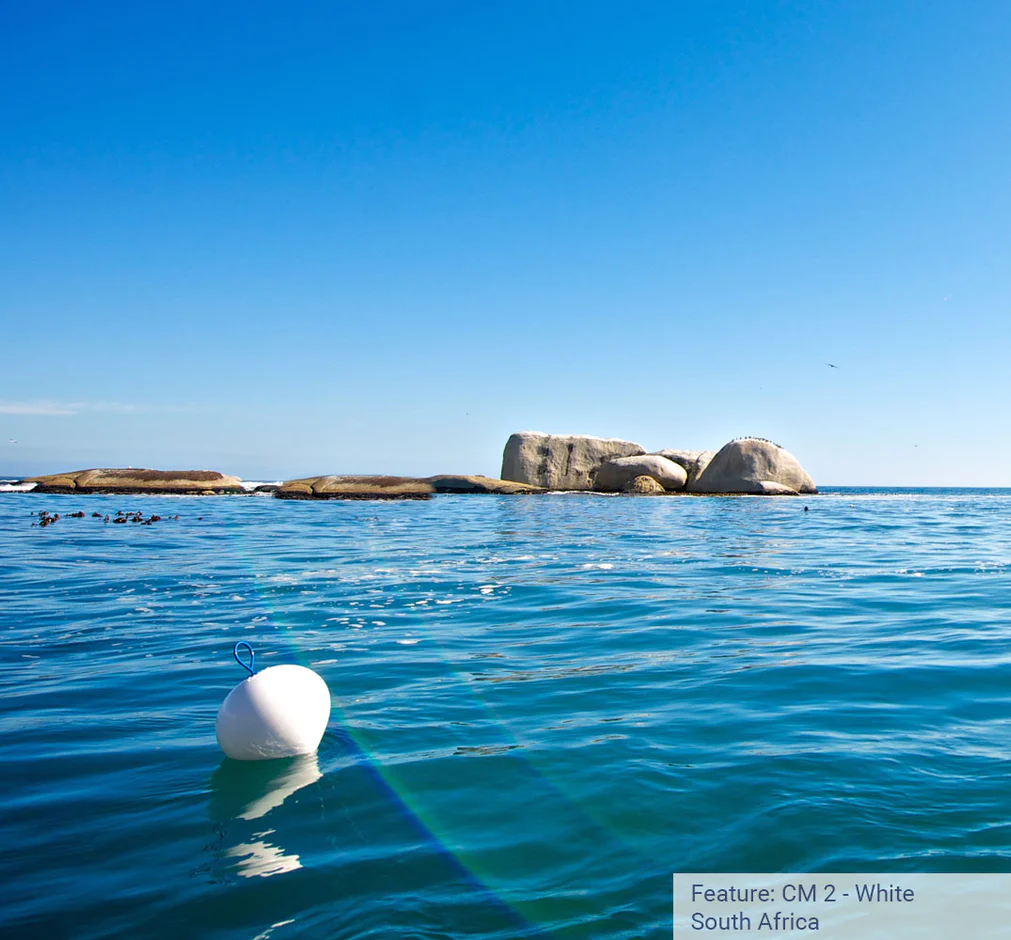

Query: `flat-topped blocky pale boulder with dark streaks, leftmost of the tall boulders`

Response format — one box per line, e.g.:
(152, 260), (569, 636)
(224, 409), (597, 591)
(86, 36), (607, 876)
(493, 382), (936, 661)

(501, 431), (646, 489)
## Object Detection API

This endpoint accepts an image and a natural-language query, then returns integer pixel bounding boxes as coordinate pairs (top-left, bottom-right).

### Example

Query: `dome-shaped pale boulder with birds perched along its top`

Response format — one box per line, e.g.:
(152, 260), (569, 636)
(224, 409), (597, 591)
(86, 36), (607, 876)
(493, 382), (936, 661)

(688, 438), (818, 495)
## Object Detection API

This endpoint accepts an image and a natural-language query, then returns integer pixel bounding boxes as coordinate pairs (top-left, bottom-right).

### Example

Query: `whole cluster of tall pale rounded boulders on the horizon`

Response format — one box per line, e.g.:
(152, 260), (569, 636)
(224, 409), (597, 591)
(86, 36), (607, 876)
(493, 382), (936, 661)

(501, 431), (818, 496)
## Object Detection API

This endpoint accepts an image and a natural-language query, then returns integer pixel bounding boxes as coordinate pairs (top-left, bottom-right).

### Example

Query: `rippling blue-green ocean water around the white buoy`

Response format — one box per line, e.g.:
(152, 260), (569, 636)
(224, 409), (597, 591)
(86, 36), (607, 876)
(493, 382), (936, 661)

(0, 490), (1011, 940)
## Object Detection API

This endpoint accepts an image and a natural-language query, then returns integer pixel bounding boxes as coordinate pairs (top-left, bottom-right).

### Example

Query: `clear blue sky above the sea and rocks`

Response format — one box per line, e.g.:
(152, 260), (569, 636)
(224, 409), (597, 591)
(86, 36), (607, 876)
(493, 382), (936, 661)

(0, 0), (1011, 485)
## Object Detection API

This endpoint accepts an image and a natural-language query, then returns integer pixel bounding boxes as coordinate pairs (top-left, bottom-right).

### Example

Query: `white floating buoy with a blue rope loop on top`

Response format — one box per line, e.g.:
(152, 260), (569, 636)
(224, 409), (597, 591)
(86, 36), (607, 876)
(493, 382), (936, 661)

(214, 643), (330, 760)
